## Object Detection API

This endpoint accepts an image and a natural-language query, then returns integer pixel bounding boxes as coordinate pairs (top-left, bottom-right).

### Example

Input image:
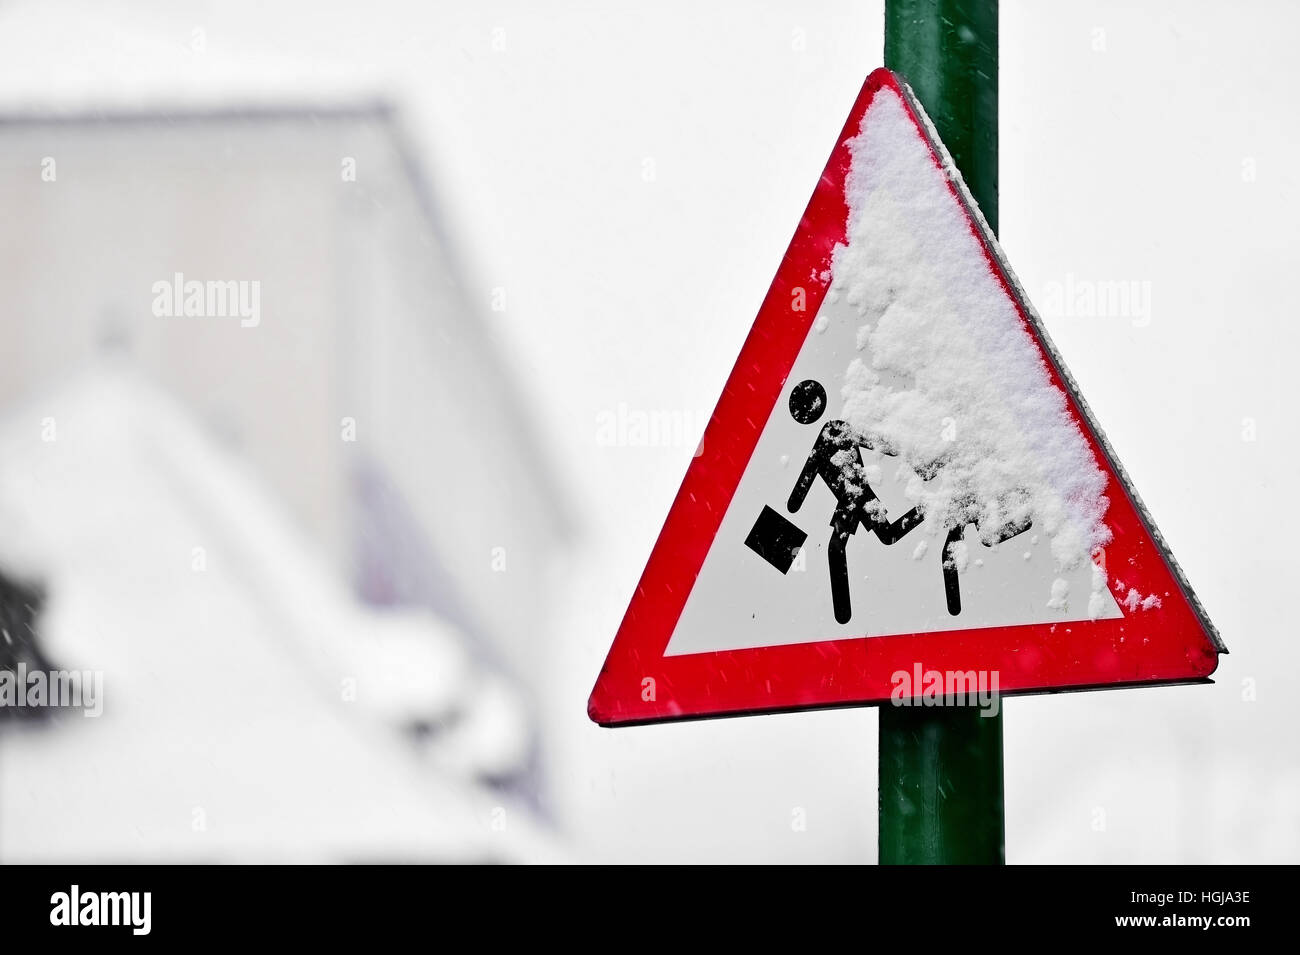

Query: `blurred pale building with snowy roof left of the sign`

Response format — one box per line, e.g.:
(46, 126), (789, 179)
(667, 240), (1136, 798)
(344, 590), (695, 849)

(0, 107), (568, 858)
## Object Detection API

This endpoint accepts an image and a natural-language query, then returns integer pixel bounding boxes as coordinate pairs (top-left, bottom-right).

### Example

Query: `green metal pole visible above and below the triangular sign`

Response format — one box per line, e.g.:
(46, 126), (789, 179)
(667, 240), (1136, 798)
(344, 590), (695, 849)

(880, 0), (1006, 865)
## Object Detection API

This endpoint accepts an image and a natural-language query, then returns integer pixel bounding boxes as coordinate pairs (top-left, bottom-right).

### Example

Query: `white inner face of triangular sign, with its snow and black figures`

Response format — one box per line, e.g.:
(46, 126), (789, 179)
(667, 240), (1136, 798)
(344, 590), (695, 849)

(666, 90), (1125, 656)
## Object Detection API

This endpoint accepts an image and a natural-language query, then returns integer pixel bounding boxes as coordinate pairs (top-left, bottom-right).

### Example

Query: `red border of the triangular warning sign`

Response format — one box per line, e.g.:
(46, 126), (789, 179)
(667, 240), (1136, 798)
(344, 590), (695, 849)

(588, 69), (1226, 725)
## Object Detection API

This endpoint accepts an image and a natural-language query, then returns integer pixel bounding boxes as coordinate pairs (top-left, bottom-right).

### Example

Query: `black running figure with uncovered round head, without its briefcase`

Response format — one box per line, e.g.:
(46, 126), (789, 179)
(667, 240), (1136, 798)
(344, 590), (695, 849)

(787, 378), (922, 624)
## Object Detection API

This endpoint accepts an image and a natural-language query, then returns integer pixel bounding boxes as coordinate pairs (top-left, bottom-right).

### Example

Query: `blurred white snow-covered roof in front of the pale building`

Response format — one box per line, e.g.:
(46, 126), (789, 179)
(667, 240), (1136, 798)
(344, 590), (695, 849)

(0, 368), (556, 861)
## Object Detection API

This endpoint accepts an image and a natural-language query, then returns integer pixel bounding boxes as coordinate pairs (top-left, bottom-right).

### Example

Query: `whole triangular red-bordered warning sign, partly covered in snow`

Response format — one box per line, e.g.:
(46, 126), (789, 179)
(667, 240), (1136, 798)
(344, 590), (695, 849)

(588, 70), (1225, 725)
